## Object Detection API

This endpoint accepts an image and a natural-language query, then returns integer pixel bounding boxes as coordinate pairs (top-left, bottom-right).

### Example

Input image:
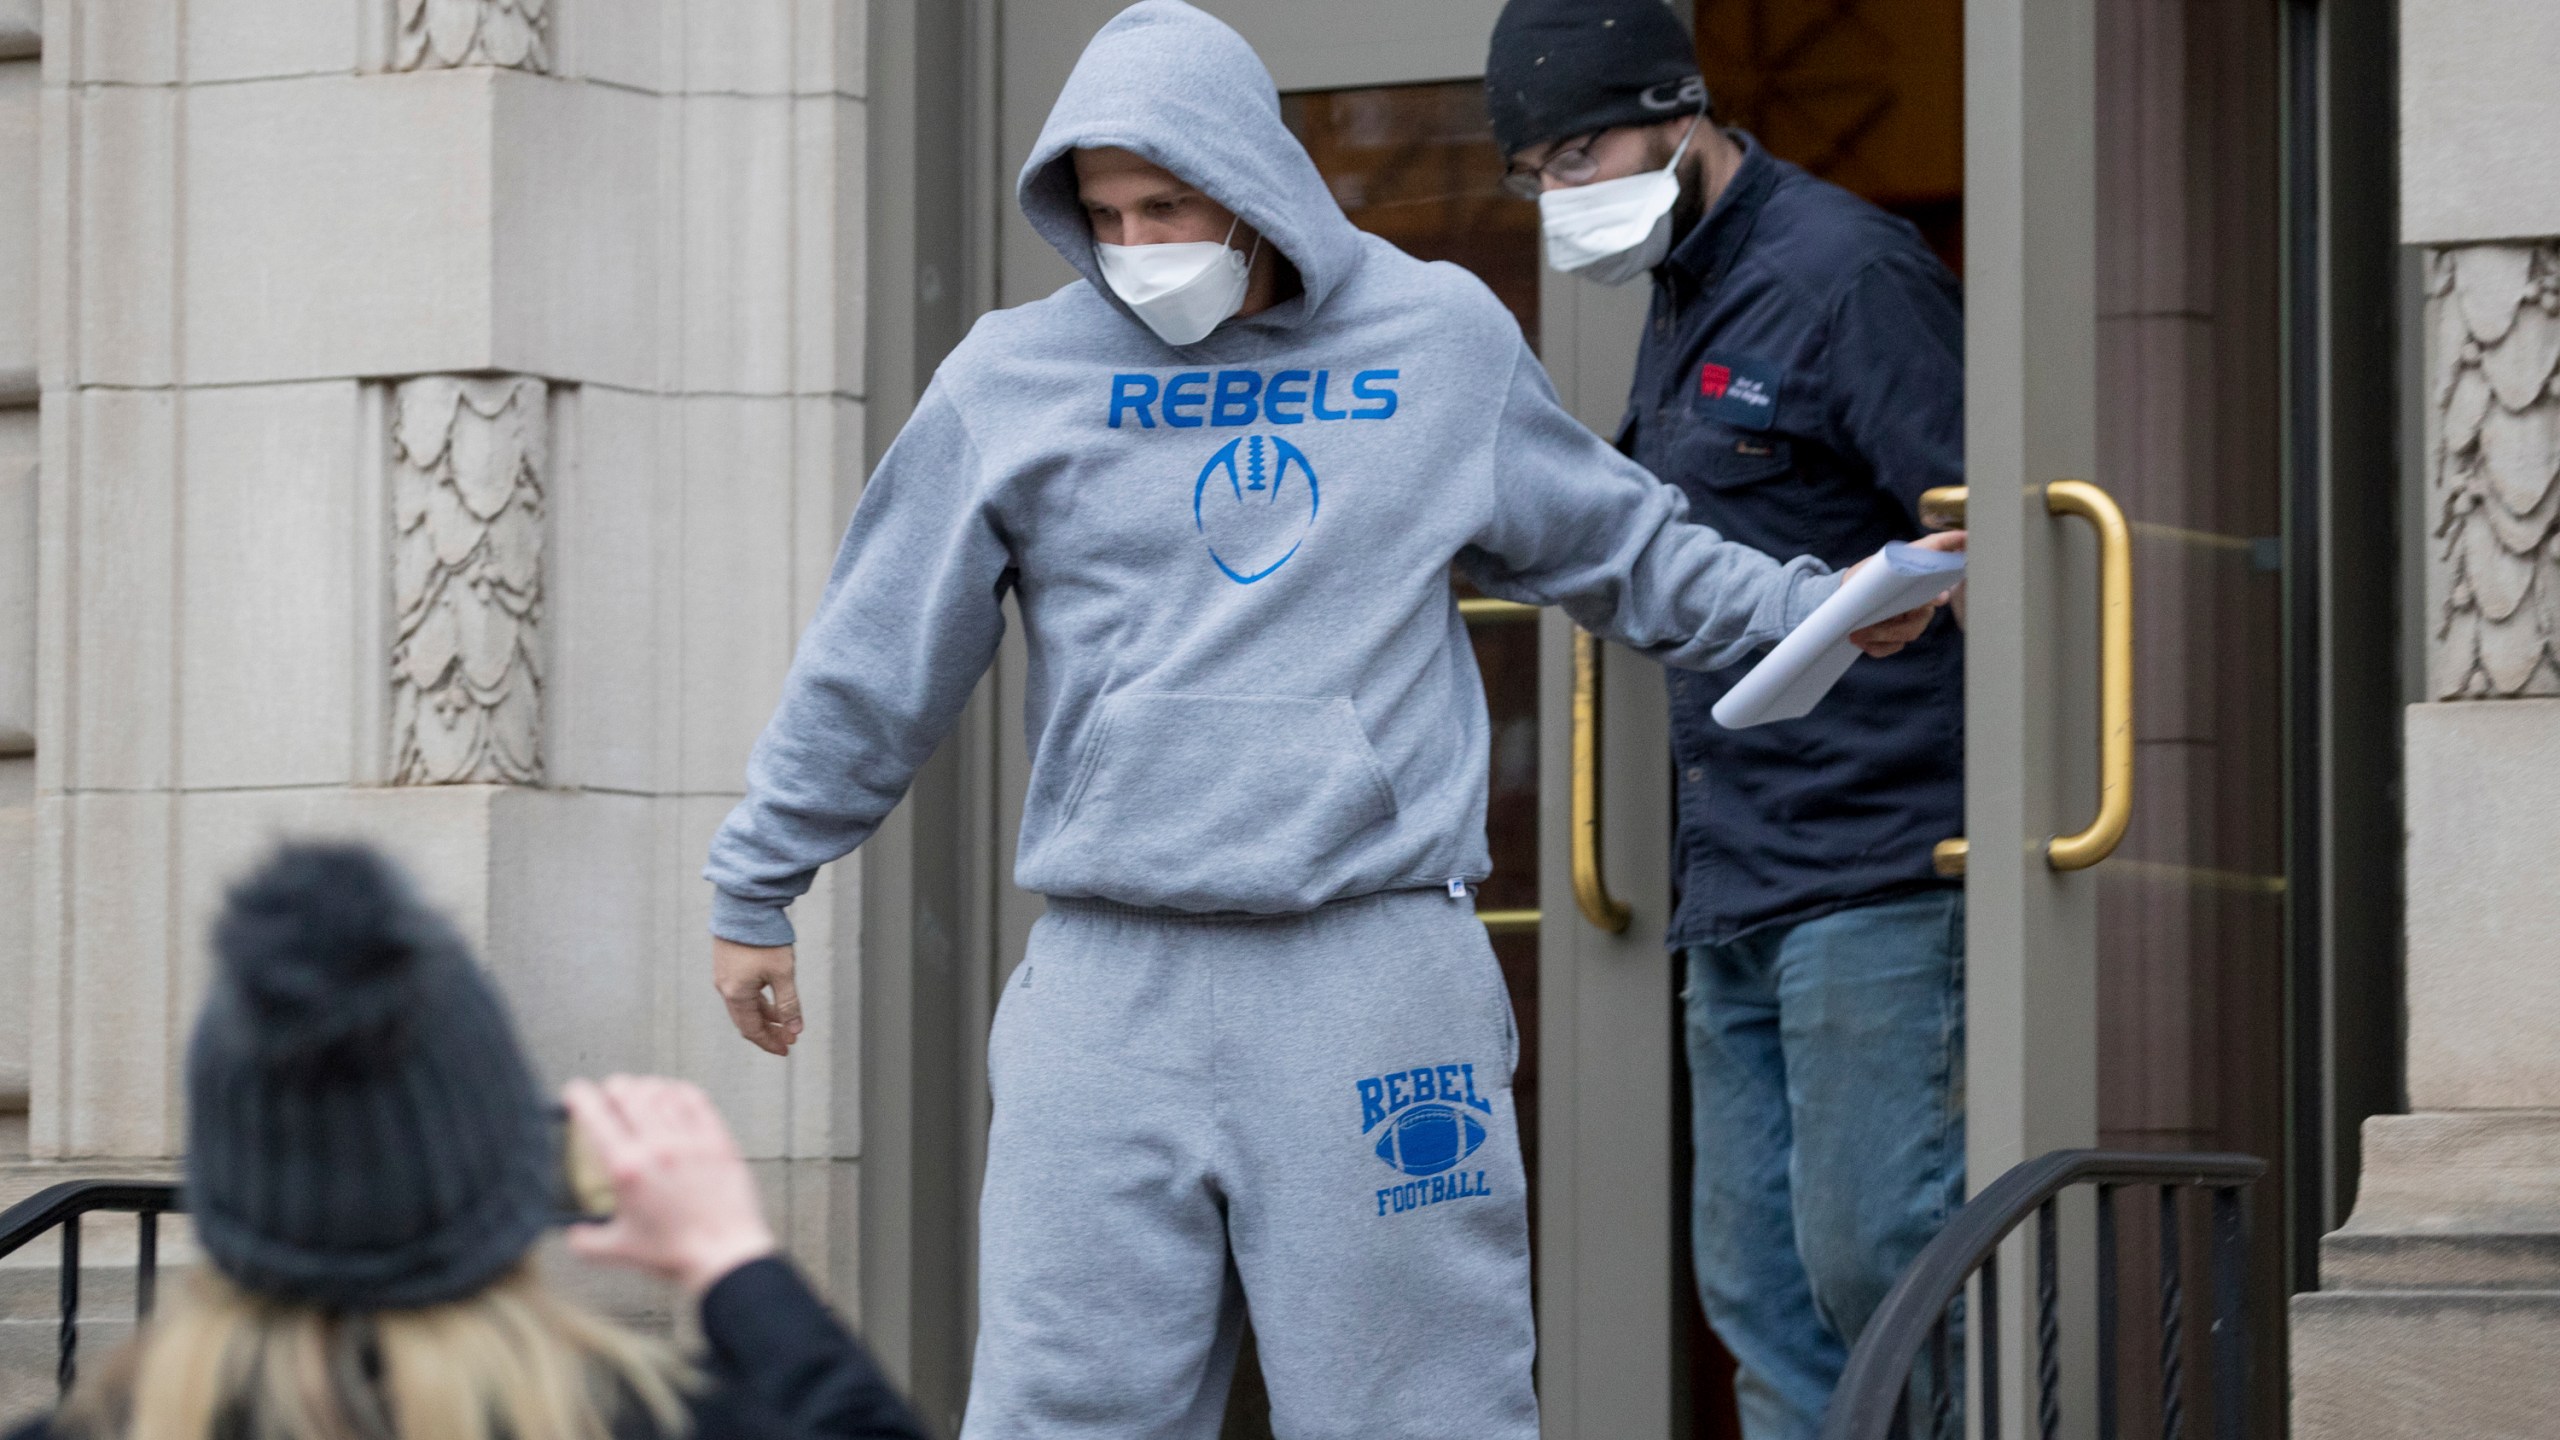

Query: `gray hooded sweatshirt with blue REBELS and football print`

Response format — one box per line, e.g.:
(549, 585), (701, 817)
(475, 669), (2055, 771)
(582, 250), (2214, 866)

(704, 0), (1838, 945)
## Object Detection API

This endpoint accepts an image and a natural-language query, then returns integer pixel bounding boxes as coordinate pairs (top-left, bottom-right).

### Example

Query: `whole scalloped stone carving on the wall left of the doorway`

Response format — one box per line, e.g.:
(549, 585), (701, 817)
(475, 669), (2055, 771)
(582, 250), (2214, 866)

(392, 374), (550, 784)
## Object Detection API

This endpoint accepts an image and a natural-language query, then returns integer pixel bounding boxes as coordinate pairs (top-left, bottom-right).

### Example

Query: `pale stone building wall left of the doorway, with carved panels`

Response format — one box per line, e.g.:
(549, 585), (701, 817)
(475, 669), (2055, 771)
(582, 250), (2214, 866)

(0, 0), (865, 1332)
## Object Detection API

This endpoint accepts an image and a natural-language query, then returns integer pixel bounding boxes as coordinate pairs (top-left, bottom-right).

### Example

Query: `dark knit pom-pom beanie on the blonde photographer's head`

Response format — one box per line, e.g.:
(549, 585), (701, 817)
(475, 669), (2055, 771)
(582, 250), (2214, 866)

(187, 843), (556, 1309)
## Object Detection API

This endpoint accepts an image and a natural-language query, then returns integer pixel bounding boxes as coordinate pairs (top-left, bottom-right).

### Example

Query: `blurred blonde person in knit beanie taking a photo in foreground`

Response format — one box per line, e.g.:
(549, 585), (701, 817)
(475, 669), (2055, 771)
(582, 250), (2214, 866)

(13, 846), (922, 1440)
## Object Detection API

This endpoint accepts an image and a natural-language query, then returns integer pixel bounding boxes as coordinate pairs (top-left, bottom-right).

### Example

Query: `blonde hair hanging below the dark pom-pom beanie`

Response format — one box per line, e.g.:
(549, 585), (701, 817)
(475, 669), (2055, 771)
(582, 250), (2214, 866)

(59, 1266), (696, 1440)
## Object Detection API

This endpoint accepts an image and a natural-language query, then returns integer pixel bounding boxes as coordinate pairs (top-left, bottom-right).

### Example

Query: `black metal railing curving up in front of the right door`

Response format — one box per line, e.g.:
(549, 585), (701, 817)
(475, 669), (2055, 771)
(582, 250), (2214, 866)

(1823, 1150), (2266, 1440)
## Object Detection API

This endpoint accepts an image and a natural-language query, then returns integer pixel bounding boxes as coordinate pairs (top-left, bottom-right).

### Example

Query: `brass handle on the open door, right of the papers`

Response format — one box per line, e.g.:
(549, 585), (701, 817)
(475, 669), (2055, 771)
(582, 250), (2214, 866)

(1920, 479), (2132, 879)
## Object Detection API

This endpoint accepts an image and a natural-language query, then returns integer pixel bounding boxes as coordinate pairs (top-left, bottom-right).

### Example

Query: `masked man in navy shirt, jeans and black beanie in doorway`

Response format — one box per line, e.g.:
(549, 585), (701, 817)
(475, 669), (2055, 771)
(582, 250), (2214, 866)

(1485, 0), (1964, 1440)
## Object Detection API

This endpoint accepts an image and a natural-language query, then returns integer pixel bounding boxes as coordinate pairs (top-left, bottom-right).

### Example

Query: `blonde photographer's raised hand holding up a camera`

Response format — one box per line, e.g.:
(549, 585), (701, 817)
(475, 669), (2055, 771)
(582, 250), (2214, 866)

(561, 1071), (788, 1297)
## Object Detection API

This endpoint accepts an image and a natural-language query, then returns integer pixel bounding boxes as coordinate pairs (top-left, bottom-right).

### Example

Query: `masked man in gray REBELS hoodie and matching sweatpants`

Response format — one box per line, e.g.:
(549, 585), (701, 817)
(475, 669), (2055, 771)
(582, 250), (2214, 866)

(707, 0), (1925, 1440)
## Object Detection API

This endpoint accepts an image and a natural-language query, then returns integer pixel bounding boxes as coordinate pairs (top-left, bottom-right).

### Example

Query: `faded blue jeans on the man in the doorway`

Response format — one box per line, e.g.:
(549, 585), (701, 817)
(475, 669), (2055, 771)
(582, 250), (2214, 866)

(1682, 889), (1964, 1440)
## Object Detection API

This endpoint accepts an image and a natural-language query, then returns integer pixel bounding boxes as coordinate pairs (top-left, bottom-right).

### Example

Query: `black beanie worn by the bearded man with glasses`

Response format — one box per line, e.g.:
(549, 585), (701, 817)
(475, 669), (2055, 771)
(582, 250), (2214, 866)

(1485, 0), (1708, 156)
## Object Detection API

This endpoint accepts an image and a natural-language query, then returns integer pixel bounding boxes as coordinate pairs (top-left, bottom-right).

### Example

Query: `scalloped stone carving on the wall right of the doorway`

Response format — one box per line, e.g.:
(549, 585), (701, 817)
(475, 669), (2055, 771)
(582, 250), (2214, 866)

(2427, 241), (2560, 700)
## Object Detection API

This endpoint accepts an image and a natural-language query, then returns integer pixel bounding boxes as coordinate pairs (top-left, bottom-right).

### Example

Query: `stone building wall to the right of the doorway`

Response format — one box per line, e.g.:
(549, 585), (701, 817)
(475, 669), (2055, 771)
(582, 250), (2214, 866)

(2294, 0), (2560, 1440)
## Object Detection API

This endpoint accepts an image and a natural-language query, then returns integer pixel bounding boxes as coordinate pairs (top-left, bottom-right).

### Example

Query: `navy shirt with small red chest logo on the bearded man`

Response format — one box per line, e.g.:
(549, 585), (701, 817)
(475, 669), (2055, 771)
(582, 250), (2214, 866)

(1618, 131), (1964, 945)
